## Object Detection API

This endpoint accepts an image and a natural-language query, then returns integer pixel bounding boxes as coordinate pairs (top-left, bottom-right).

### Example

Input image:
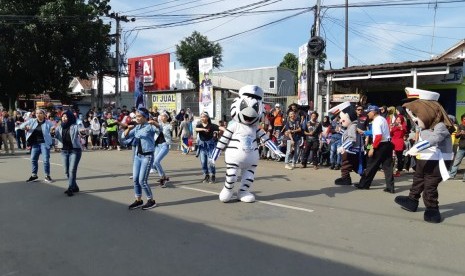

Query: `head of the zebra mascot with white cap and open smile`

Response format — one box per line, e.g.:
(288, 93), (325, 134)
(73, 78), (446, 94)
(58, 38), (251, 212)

(231, 85), (263, 125)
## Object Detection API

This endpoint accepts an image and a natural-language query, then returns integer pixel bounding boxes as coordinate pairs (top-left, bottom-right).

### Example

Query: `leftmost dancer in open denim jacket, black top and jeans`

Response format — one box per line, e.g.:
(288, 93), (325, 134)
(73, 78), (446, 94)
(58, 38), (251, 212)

(19, 109), (54, 183)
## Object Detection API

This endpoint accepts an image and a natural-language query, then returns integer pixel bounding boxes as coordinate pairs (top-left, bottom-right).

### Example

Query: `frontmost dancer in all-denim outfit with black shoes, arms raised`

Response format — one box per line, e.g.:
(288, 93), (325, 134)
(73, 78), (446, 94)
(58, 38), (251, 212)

(122, 108), (159, 210)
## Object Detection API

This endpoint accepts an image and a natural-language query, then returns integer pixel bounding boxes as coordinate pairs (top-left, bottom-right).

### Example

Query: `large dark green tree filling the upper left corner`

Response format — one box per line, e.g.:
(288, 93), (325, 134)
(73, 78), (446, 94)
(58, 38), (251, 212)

(0, 0), (111, 108)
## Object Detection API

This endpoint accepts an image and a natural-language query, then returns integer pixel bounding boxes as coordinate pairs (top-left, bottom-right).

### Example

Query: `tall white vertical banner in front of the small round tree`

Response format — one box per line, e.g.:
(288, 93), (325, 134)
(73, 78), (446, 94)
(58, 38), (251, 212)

(199, 57), (214, 118)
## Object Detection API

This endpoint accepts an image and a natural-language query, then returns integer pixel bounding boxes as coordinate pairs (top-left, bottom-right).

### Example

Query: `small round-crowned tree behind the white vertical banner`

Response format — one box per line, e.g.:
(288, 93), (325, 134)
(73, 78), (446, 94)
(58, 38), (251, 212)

(176, 31), (223, 89)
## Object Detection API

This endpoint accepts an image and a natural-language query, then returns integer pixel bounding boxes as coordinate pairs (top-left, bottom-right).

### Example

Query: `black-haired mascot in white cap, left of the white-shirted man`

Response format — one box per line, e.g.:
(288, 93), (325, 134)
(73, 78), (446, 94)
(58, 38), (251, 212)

(328, 102), (364, 185)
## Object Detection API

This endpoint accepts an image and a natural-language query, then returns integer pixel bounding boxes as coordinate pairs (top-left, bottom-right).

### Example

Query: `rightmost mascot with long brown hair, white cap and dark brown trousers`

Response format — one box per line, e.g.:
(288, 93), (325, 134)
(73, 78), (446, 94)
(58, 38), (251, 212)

(395, 87), (454, 223)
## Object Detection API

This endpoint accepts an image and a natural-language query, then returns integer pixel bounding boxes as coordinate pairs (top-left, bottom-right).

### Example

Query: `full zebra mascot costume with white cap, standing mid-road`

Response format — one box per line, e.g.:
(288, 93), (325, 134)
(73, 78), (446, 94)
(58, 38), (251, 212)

(211, 85), (284, 202)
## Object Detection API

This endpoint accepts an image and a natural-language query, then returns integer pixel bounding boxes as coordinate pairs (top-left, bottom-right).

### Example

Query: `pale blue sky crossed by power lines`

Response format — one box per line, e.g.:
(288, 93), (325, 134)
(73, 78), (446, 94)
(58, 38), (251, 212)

(108, 0), (465, 71)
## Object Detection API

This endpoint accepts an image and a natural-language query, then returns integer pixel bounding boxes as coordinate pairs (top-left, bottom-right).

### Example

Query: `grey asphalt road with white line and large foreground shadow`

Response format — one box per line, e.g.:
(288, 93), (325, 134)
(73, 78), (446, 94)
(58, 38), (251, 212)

(0, 151), (465, 276)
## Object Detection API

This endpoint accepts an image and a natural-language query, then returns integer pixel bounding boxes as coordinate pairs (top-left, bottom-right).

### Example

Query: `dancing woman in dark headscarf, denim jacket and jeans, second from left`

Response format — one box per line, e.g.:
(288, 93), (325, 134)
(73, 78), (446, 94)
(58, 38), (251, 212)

(55, 110), (85, 196)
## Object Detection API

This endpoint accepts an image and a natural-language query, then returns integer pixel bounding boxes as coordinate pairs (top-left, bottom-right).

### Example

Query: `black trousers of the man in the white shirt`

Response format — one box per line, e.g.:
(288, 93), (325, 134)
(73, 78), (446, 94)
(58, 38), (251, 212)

(359, 142), (394, 189)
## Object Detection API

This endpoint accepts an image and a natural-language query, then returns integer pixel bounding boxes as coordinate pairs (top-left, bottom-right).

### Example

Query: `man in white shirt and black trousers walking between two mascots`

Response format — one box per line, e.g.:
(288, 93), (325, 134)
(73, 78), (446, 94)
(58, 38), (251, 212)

(354, 105), (395, 194)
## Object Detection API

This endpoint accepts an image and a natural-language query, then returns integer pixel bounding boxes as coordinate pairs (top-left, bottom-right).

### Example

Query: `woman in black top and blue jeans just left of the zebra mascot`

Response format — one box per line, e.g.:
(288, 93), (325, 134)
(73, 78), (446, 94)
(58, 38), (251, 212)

(195, 111), (219, 183)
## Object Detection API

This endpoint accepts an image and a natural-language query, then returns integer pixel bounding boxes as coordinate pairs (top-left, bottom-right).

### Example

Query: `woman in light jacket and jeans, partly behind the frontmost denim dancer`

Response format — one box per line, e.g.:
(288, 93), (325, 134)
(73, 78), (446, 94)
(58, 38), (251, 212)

(153, 111), (172, 188)
